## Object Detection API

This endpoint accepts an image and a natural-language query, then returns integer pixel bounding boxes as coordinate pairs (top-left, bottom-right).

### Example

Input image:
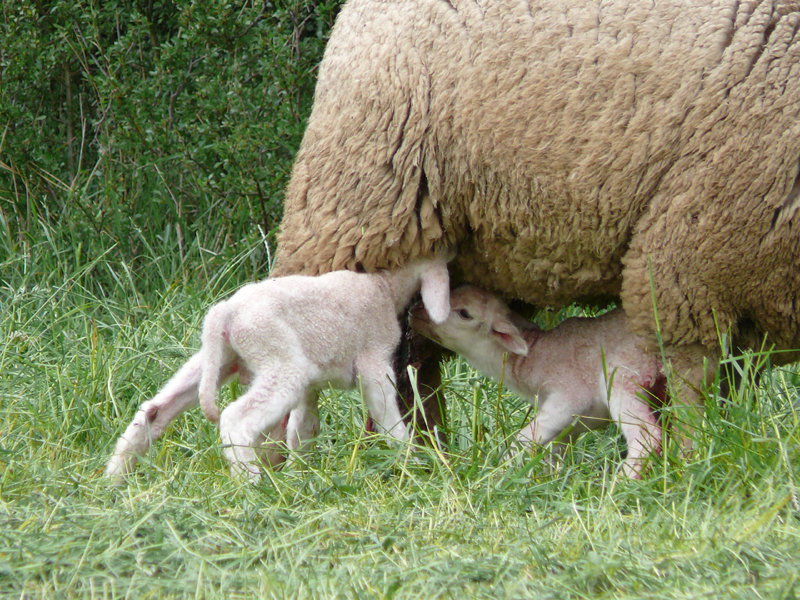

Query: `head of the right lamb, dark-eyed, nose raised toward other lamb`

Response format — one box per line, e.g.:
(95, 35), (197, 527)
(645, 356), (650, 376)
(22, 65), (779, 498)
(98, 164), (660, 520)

(410, 285), (528, 360)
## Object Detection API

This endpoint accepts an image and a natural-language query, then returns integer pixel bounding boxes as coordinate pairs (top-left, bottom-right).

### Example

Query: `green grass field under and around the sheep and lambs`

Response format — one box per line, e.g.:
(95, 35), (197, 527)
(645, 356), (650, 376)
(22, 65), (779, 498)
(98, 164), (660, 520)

(0, 225), (800, 599)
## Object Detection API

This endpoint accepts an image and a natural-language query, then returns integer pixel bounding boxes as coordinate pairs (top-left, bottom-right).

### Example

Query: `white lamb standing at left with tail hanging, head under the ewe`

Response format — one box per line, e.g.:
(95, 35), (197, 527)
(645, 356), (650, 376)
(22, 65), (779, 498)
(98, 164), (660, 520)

(106, 259), (450, 481)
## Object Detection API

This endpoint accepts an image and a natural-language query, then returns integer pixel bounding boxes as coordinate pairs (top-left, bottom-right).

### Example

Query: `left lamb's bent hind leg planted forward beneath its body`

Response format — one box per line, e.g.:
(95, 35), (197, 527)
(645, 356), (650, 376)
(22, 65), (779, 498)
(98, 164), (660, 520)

(219, 379), (305, 483)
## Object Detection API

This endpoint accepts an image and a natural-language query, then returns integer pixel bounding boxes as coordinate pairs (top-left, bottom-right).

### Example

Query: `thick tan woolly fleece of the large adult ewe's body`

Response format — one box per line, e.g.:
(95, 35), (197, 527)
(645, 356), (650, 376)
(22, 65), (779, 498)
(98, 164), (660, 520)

(277, 0), (800, 358)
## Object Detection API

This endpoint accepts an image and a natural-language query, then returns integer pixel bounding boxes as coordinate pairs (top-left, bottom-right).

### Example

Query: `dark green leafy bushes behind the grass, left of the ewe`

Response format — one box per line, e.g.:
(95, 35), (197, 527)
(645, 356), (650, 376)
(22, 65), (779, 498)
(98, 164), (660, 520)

(0, 0), (340, 288)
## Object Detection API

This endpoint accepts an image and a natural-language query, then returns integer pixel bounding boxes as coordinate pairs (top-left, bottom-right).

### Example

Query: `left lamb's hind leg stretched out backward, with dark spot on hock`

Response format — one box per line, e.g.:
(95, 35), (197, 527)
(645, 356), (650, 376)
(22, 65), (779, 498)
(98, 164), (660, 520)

(106, 352), (237, 483)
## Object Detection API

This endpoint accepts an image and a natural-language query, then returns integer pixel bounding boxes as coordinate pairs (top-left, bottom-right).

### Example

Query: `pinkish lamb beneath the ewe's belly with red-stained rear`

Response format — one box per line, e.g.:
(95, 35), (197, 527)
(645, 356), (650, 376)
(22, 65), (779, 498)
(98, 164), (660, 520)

(411, 286), (666, 479)
